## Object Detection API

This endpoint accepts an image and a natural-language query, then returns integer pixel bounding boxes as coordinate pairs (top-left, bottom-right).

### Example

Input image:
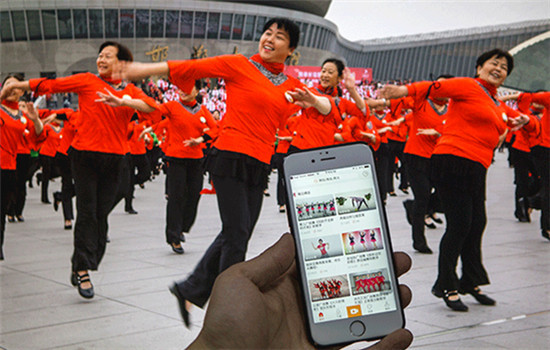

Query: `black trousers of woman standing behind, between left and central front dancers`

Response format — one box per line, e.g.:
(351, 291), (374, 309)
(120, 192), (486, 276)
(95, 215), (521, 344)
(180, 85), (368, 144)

(166, 158), (203, 244)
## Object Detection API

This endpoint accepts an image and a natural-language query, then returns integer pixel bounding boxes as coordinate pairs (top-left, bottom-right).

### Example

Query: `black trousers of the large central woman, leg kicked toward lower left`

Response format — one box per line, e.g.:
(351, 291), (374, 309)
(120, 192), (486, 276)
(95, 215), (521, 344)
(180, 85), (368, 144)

(177, 175), (265, 307)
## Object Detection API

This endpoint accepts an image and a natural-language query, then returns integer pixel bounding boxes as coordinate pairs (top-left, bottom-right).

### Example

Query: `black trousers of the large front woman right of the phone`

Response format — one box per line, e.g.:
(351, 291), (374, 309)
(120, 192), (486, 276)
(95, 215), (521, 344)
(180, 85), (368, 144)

(432, 155), (489, 290)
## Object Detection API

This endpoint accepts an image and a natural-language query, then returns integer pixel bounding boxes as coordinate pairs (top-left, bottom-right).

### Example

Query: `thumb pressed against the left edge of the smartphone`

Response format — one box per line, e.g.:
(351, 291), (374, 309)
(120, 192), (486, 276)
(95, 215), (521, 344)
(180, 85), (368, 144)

(236, 233), (295, 289)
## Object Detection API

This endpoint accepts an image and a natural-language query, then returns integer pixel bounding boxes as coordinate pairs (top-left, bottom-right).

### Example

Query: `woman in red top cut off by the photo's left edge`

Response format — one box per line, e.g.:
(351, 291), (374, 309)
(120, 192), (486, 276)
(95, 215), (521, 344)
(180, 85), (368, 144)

(0, 75), (44, 260)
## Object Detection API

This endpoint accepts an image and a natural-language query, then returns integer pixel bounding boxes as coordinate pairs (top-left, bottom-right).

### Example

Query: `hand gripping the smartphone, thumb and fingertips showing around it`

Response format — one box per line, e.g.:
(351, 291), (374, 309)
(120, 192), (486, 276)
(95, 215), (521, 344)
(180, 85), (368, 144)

(189, 234), (413, 349)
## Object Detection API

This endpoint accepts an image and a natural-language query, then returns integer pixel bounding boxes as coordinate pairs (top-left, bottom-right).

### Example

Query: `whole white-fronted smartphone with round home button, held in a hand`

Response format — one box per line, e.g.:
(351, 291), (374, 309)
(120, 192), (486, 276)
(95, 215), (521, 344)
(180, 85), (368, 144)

(283, 143), (405, 346)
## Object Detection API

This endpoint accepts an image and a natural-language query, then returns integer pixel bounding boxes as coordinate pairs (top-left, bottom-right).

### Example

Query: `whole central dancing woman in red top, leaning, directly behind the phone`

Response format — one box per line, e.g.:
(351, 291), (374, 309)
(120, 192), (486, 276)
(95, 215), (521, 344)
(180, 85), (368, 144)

(117, 18), (334, 325)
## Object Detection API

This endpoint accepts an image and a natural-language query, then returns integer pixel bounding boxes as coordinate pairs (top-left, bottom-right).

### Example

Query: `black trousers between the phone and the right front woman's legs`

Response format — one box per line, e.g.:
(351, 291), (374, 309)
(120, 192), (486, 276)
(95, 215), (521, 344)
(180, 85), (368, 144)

(403, 153), (432, 247)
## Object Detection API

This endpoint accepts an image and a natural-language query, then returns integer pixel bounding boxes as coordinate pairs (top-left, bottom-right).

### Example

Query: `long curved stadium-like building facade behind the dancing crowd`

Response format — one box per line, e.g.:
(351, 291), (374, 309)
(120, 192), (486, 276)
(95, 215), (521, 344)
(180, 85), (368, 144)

(0, 0), (550, 88)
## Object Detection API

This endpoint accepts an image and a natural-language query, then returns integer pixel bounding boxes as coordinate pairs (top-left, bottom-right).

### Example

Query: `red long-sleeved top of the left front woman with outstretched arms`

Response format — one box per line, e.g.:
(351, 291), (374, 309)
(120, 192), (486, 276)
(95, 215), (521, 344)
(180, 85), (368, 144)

(29, 73), (156, 154)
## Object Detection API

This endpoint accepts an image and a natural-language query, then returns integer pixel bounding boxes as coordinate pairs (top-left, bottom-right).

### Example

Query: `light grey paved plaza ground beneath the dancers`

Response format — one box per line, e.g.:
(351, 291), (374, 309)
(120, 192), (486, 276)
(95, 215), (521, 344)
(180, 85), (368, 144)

(0, 153), (550, 350)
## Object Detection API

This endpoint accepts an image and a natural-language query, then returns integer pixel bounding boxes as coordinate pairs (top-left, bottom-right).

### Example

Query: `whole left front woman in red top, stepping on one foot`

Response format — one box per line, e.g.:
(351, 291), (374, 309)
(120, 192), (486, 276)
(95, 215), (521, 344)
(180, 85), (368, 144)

(1, 41), (160, 298)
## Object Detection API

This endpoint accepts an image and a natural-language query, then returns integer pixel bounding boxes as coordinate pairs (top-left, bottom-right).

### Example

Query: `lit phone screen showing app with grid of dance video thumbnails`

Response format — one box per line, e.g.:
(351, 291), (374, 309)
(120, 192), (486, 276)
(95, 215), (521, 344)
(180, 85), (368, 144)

(289, 164), (397, 323)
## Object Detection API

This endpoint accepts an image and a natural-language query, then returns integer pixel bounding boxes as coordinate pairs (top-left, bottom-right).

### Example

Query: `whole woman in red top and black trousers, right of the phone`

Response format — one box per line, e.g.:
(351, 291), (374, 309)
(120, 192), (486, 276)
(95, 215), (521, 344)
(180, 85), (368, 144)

(382, 49), (529, 311)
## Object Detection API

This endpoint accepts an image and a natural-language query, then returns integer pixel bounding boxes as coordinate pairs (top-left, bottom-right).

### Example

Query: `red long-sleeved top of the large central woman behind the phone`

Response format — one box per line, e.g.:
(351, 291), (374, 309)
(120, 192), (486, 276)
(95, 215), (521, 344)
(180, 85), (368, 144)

(168, 55), (303, 164)
